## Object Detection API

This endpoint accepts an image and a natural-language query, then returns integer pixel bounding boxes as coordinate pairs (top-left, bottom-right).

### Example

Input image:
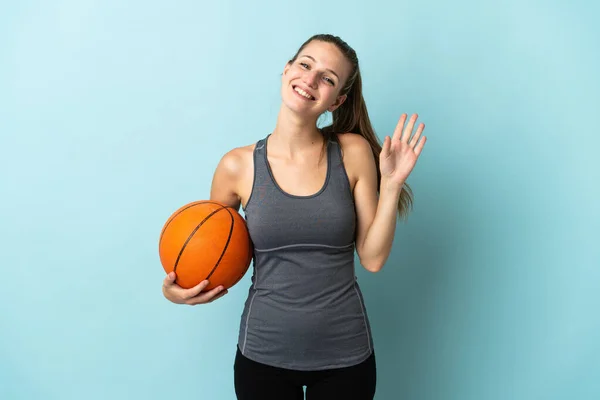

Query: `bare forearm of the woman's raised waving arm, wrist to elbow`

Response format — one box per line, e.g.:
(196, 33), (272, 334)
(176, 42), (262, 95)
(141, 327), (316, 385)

(359, 179), (402, 272)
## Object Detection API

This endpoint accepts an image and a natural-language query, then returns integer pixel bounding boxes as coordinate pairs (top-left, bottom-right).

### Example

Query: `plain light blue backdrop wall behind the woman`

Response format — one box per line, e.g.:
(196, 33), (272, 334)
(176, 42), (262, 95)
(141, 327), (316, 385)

(0, 0), (600, 400)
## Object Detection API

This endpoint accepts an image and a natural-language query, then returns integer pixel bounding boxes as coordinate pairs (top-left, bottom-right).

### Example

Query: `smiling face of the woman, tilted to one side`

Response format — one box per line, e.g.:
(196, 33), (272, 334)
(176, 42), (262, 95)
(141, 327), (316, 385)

(281, 41), (352, 117)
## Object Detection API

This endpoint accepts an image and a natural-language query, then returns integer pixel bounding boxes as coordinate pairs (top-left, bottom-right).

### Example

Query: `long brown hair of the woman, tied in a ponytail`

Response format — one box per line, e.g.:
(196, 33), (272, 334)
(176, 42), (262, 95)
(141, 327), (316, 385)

(289, 34), (413, 219)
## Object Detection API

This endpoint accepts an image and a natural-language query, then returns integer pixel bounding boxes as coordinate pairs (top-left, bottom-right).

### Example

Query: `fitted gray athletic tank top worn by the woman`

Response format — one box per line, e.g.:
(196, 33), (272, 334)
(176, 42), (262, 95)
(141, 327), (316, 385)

(238, 135), (373, 371)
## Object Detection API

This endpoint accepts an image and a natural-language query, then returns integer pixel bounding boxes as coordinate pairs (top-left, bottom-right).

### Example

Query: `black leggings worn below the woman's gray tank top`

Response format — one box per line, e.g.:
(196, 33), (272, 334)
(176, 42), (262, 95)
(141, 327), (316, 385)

(234, 348), (377, 400)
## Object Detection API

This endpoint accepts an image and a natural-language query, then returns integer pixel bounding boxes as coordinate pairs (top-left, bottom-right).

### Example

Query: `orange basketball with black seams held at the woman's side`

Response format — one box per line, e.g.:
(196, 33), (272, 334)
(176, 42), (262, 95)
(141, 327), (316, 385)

(158, 200), (253, 290)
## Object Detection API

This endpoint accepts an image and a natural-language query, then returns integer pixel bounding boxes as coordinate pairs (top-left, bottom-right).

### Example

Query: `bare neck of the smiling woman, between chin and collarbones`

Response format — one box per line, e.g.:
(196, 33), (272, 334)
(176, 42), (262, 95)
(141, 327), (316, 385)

(270, 104), (324, 157)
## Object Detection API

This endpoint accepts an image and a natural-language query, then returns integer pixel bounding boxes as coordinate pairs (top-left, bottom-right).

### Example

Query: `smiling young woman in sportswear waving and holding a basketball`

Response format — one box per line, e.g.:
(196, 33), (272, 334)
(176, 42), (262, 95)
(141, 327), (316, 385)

(163, 35), (426, 400)
